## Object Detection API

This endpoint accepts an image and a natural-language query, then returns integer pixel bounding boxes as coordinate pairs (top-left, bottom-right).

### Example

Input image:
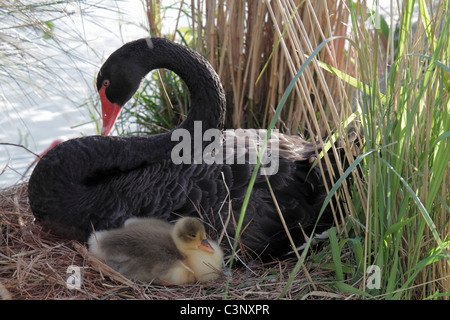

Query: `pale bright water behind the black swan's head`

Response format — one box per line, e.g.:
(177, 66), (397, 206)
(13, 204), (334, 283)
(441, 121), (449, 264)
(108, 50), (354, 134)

(0, 0), (147, 188)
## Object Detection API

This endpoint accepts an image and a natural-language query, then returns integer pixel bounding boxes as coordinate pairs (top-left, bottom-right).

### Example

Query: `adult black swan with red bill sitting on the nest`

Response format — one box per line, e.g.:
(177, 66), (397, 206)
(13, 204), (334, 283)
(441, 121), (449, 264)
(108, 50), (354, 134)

(28, 38), (356, 259)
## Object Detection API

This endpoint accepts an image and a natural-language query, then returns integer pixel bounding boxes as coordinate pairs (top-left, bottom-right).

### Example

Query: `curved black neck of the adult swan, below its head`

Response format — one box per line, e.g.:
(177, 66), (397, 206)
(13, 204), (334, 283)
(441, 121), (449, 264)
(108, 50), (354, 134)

(137, 38), (225, 131)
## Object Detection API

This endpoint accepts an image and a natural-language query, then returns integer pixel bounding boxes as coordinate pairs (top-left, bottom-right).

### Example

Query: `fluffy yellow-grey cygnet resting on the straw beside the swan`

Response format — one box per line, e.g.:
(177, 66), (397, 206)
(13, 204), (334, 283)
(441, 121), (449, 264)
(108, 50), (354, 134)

(88, 218), (223, 285)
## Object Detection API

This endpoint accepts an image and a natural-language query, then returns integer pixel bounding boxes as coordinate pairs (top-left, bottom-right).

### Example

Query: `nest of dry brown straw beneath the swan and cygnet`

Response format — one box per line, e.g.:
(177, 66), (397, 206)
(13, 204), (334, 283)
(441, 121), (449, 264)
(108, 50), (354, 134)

(0, 183), (345, 300)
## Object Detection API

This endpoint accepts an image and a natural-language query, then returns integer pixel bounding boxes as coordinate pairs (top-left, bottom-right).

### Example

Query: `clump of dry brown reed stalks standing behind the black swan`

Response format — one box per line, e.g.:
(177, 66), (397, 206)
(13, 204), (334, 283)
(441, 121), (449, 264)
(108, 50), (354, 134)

(145, 0), (355, 136)
